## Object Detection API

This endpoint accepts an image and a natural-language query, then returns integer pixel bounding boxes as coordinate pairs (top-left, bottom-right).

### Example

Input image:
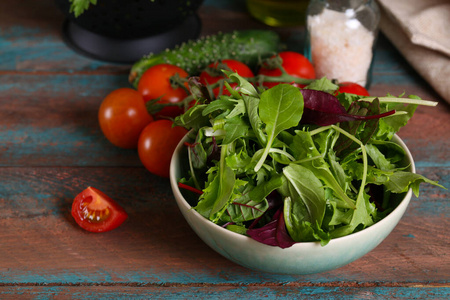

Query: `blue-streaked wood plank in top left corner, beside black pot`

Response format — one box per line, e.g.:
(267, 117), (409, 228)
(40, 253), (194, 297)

(0, 0), (127, 72)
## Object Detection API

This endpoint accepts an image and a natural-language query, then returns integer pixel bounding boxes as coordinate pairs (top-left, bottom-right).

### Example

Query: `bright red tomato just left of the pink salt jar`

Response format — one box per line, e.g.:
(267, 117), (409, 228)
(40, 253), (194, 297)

(258, 51), (316, 88)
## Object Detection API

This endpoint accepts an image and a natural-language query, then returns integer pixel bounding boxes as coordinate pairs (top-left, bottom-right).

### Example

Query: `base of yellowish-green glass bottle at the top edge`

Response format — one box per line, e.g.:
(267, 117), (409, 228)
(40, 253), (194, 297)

(247, 0), (309, 27)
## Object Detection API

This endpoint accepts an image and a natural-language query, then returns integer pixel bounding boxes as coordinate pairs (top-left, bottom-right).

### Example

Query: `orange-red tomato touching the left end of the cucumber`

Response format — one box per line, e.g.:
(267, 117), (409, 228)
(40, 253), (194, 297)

(137, 64), (188, 118)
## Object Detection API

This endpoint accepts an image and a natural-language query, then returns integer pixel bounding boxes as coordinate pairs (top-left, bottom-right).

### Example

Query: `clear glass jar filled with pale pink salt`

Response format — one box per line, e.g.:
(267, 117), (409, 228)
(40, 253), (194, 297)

(305, 0), (380, 87)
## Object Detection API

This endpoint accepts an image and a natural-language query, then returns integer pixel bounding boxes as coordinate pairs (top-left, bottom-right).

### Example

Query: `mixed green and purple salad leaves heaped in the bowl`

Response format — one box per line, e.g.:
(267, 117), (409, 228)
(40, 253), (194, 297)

(175, 71), (440, 248)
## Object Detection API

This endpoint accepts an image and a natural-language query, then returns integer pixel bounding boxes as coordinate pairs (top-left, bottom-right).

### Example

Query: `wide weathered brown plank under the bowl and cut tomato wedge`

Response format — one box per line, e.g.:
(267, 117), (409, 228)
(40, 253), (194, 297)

(0, 168), (450, 285)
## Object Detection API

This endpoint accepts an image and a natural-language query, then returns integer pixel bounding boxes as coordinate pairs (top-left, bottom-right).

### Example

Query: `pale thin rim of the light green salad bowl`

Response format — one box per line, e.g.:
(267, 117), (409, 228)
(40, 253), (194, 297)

(169, 133), (416, 251)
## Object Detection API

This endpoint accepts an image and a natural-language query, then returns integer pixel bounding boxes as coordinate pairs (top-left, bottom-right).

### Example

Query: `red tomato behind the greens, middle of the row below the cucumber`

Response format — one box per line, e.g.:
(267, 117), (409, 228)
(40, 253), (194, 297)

(200, 59), (255, 97)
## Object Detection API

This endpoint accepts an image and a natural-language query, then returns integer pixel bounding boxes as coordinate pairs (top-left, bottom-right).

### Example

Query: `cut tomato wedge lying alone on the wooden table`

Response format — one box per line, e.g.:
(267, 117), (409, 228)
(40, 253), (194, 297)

(72, 187), (128, 232)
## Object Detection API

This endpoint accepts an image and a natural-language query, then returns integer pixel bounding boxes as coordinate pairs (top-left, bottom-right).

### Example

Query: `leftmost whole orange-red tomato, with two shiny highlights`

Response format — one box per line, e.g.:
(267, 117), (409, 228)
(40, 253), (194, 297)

(98, 88), (153, 149)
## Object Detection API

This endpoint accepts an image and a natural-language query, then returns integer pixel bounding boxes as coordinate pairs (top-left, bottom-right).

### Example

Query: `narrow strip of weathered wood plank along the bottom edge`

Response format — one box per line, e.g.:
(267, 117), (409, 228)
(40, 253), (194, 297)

(0, 284), (450, 300)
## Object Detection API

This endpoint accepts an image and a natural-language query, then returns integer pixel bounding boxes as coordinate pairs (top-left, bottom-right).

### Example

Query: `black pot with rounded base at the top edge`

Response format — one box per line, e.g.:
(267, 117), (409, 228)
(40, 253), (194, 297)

(56, 0), (203, 63)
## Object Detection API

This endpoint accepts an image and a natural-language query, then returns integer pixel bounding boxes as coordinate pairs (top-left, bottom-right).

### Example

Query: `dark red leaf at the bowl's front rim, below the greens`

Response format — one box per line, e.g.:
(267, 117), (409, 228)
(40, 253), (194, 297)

(247, 209), (295, 248)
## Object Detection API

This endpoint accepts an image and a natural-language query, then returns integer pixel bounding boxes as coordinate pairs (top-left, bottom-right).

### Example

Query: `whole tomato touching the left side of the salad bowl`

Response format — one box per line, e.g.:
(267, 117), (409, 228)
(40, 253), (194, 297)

(138, 120), (187, 177)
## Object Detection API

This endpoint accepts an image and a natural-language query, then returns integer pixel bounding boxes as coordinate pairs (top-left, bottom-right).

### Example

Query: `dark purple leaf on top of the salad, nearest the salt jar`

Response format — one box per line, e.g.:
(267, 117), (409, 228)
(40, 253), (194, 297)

(300, 89), (395, 126)
